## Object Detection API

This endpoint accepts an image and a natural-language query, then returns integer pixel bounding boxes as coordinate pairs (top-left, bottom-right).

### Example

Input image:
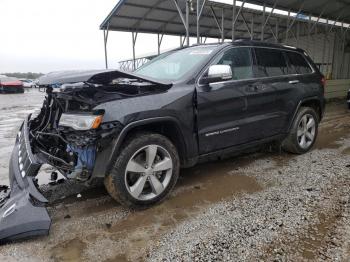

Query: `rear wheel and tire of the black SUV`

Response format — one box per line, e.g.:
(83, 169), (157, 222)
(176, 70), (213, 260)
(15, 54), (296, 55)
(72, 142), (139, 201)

(282, 107), (319, 154)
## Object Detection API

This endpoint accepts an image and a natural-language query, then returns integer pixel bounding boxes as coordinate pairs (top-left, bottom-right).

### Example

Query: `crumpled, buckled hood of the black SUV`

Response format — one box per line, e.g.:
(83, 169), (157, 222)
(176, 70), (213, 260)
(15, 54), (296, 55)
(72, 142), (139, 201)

(39, 69), (170, 86)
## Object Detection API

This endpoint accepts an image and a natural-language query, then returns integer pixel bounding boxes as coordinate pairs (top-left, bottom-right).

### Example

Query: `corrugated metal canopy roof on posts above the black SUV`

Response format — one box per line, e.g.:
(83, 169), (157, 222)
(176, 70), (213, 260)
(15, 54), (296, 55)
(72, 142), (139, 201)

(100, 0), (350, 39)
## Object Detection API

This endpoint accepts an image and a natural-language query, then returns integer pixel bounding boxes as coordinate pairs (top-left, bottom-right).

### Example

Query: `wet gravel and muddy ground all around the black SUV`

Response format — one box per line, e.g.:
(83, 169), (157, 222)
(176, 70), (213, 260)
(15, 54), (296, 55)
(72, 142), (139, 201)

(0, 90), (350, 261)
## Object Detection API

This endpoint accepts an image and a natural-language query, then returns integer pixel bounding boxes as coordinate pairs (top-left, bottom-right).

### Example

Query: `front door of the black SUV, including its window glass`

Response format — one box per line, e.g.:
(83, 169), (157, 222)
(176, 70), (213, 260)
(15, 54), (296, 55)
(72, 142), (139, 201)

(197, 47), (275, 154)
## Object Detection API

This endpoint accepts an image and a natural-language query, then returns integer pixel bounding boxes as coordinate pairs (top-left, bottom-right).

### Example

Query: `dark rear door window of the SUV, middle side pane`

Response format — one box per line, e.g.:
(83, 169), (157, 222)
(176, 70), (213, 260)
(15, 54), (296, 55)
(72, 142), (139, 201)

(255, 48), (289, 77)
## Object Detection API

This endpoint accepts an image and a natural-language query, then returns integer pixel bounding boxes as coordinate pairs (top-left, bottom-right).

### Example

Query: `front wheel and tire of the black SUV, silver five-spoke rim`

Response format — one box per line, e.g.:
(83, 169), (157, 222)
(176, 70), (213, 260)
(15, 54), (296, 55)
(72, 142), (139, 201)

(105, 133), (180, 208)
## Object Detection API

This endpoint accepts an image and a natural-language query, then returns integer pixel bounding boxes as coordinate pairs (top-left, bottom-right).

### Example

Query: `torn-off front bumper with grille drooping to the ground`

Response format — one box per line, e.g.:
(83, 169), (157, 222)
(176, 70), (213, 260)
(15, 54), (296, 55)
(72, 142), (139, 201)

(0, 117), (51, 243)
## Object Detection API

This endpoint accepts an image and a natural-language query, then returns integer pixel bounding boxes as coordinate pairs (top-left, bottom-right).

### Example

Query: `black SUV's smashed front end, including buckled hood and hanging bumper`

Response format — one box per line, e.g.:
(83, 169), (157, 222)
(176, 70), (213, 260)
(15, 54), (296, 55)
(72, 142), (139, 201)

(0, 71), (168, 243)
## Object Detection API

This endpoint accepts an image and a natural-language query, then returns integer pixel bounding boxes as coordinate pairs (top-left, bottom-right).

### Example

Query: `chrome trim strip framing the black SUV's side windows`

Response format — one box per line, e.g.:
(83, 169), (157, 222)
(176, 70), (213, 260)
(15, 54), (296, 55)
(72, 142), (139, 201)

(196, 46), (316, 87)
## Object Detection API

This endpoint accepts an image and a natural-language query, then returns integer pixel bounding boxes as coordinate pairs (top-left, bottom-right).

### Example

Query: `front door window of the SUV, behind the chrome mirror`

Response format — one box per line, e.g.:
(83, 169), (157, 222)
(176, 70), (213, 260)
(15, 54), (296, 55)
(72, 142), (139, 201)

(214, 47), (254, 80)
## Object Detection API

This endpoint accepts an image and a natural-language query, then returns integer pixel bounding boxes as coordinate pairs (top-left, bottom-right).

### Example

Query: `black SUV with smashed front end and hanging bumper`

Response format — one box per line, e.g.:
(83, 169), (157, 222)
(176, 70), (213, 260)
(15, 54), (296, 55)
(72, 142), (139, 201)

(0, 41), (325, 242)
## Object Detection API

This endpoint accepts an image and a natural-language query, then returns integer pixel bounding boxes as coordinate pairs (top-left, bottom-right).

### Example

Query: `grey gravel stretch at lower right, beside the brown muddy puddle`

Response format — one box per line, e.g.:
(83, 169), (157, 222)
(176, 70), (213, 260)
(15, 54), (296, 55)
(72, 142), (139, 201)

(149, 143), (350, 261)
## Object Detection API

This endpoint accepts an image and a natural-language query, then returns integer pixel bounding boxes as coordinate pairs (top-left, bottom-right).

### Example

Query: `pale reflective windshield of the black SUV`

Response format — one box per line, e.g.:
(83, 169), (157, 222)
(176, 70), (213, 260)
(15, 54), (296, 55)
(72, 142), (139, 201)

(134, 46), (216, 80)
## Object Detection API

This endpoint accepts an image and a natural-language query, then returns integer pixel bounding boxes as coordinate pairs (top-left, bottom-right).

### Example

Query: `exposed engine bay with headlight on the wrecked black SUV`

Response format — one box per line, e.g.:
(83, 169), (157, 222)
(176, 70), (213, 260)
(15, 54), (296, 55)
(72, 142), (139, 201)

(29, 70), (169, 181)
